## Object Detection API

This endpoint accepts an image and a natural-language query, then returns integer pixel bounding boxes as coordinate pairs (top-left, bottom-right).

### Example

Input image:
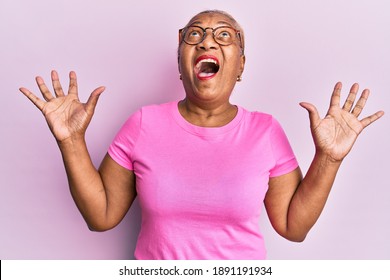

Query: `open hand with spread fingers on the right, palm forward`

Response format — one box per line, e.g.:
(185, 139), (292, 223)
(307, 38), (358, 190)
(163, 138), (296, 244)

(300, 82), (384, 162)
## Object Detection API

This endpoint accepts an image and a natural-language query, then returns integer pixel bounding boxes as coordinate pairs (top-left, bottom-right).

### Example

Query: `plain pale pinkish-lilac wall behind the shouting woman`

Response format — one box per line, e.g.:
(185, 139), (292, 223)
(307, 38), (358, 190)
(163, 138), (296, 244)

(0, 0), (390, 259)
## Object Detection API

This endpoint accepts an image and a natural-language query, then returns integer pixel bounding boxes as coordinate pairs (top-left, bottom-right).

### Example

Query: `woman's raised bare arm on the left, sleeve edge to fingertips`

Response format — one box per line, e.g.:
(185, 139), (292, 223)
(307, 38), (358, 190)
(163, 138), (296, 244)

(20, 71), (136, 231)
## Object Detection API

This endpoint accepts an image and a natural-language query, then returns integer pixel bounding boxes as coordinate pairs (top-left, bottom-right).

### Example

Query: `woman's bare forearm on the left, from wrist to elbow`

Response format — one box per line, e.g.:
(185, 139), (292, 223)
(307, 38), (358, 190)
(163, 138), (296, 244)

(59, 138), (107, 229)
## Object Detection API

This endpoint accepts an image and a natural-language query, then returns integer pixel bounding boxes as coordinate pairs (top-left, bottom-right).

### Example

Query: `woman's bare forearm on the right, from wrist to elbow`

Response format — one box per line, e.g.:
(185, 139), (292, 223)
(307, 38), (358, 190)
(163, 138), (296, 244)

(287, 153), (341, 241)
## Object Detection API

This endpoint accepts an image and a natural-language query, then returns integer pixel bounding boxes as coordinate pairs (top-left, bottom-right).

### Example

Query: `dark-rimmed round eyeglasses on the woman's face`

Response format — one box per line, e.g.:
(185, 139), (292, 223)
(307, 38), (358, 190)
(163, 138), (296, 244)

(179, 25), (242, 48)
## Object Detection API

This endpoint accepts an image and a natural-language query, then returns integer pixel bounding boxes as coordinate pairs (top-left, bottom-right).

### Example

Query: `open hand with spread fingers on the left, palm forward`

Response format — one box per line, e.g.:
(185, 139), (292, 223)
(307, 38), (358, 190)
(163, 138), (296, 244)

(19, 71), (105, 144)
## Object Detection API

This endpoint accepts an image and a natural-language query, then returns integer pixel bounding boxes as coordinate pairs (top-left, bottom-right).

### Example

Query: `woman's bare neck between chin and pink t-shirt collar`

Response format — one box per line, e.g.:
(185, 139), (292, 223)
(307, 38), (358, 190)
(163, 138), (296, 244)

(179, 98), (237, 127)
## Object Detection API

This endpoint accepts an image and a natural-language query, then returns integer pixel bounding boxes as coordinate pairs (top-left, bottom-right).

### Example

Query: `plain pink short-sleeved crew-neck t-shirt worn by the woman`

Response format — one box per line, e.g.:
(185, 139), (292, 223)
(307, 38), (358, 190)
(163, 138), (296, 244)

(109, 102), (298, 259)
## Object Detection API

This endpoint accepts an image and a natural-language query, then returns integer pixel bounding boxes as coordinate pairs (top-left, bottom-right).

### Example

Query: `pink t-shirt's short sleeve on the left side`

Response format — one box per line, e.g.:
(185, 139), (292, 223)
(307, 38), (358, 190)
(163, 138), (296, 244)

(108, 110), (142, 170)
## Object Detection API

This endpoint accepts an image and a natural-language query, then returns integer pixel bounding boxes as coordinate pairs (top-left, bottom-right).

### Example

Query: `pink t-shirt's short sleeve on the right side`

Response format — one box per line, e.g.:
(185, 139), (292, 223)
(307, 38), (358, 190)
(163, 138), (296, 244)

(270, 118), (298, 177)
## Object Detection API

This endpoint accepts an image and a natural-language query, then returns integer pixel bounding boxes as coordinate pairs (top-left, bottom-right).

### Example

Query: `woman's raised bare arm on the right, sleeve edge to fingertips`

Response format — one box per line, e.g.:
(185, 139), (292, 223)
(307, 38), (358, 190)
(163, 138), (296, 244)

(265, 82), (384, 241)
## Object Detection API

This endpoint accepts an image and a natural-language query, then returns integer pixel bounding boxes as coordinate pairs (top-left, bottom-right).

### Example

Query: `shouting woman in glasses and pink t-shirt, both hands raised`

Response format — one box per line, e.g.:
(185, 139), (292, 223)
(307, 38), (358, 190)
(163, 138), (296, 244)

(20, 11), (384, 259)
